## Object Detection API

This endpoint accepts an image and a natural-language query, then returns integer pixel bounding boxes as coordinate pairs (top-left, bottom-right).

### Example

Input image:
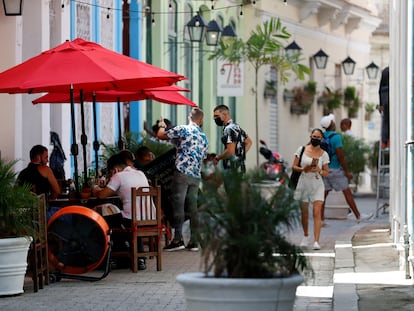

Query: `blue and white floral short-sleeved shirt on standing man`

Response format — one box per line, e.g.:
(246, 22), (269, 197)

(165, 122), (208, 178)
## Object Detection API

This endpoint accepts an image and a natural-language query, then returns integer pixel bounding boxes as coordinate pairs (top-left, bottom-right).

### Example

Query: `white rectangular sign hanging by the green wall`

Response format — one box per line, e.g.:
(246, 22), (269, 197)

(217, 60), (243, 96)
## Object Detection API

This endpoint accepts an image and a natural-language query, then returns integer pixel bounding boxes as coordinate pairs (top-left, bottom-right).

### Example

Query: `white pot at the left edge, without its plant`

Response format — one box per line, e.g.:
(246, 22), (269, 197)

(0, 236), (32, 296)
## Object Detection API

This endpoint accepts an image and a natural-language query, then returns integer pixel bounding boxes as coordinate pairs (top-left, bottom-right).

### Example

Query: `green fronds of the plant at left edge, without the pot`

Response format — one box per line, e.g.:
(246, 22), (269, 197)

(0, 159), (39, 237)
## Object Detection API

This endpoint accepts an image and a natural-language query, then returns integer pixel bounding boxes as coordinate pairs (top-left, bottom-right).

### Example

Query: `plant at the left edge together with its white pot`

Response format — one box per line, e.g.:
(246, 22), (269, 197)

(0, 159), (39, 296)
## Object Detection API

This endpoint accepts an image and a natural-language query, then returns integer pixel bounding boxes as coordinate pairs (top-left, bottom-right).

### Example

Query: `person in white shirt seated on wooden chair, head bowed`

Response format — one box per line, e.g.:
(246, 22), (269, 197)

(93, 153), (153, 270)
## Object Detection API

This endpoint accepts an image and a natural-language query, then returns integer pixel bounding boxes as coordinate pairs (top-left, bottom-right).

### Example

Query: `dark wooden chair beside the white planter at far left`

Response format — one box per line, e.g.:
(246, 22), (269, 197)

(27, 194), (49, 293)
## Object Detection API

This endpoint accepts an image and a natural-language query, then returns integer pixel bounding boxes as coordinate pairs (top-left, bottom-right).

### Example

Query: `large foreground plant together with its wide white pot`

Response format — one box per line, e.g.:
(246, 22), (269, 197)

(177, 171), (311, 311)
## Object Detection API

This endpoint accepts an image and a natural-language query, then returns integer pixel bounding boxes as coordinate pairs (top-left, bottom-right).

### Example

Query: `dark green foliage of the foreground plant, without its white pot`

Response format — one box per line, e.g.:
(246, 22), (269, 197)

(197, 171), (311, 278)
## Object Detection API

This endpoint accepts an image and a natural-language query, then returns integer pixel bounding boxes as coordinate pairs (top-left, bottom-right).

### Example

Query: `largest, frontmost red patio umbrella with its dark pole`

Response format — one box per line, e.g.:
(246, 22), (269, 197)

(0, 38), (185, 193)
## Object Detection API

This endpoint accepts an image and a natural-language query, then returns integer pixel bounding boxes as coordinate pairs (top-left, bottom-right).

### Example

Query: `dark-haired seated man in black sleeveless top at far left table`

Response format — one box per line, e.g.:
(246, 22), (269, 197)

(17, 145), (60, 200)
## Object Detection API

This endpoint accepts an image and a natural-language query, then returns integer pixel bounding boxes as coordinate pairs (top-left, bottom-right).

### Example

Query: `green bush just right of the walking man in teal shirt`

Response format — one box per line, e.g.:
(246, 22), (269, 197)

(342, 135), (371, 188)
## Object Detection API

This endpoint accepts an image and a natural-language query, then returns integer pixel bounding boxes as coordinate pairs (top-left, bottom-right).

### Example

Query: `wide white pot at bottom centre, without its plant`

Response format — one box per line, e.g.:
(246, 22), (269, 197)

(177, 272), (304, 311)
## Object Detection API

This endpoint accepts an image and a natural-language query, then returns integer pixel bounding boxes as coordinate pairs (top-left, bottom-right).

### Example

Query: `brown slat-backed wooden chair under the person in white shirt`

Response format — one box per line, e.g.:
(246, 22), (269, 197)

(111, 186), (163, 273)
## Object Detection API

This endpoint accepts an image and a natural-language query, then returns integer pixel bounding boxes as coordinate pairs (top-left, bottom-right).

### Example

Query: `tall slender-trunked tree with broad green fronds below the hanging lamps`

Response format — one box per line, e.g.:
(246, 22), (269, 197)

(209, 18), (310, 166)
